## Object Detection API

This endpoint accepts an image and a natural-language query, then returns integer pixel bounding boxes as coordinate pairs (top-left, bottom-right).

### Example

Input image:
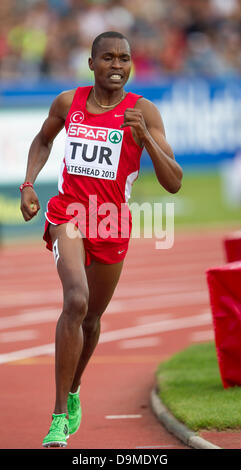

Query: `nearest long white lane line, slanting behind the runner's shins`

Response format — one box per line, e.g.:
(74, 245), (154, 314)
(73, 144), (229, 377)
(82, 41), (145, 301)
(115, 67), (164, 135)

(0, 313), (212, 364)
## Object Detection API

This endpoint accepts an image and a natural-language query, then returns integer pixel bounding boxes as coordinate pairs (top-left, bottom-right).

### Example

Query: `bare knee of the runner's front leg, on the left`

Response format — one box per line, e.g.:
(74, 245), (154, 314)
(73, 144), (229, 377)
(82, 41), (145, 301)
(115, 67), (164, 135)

(63, 286), (88, 323)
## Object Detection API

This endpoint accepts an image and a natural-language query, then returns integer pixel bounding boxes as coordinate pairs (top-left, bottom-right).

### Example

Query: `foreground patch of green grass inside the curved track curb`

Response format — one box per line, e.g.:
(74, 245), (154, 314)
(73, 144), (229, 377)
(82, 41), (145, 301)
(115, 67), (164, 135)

(157, 342), (241, 431)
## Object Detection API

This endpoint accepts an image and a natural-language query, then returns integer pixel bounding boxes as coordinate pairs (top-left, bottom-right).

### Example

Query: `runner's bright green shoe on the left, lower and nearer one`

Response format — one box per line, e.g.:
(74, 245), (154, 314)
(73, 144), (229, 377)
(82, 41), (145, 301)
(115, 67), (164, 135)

(43, 413), (69, 447)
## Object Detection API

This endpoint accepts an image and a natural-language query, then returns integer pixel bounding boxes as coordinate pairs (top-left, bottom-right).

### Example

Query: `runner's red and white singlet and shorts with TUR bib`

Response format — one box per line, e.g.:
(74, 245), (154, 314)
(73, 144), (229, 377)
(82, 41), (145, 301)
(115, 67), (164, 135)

(43, 86), (142, 265)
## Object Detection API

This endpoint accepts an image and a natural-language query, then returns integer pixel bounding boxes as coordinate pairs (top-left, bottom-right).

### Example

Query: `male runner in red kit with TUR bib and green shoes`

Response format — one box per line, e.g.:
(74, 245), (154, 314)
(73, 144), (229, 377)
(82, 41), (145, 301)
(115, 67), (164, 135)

(20, 32), (182, 447)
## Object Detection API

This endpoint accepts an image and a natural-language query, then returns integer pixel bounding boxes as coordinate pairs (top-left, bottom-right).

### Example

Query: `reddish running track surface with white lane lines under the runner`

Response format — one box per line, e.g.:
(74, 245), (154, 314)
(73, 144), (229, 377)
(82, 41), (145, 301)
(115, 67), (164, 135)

(0, 230), (228, 452)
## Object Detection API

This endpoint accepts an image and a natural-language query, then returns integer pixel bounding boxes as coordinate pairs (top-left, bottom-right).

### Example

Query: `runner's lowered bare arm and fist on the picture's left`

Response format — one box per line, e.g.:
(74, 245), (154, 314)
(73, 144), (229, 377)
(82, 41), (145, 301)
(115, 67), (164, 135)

(21, 92), (71, 221)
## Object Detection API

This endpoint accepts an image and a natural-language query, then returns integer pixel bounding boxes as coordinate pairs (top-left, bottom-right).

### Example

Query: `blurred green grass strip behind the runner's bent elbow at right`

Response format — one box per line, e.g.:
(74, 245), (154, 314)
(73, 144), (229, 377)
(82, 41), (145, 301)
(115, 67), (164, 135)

(130, 171), (241, 228)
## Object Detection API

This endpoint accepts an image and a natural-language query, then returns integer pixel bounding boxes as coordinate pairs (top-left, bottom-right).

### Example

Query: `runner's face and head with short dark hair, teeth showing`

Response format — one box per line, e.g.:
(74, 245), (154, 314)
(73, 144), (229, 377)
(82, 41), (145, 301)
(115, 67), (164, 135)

(89, 38), (131, 91)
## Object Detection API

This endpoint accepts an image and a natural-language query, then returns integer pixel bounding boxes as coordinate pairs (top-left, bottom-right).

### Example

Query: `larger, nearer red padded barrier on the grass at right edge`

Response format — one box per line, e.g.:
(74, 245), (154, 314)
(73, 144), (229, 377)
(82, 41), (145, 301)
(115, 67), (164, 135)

(206, 261), (241, 388)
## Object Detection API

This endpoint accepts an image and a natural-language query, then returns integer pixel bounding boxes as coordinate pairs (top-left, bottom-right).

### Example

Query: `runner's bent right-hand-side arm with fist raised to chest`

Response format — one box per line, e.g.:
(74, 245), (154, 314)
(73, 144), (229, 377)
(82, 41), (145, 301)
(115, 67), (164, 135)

(121, 98), (183, 193)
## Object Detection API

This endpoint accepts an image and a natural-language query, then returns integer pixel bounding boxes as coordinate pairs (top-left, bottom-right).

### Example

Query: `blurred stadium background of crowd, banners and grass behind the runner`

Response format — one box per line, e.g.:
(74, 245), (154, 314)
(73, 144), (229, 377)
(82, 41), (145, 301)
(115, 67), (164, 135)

(0, 0), (241, 242)
